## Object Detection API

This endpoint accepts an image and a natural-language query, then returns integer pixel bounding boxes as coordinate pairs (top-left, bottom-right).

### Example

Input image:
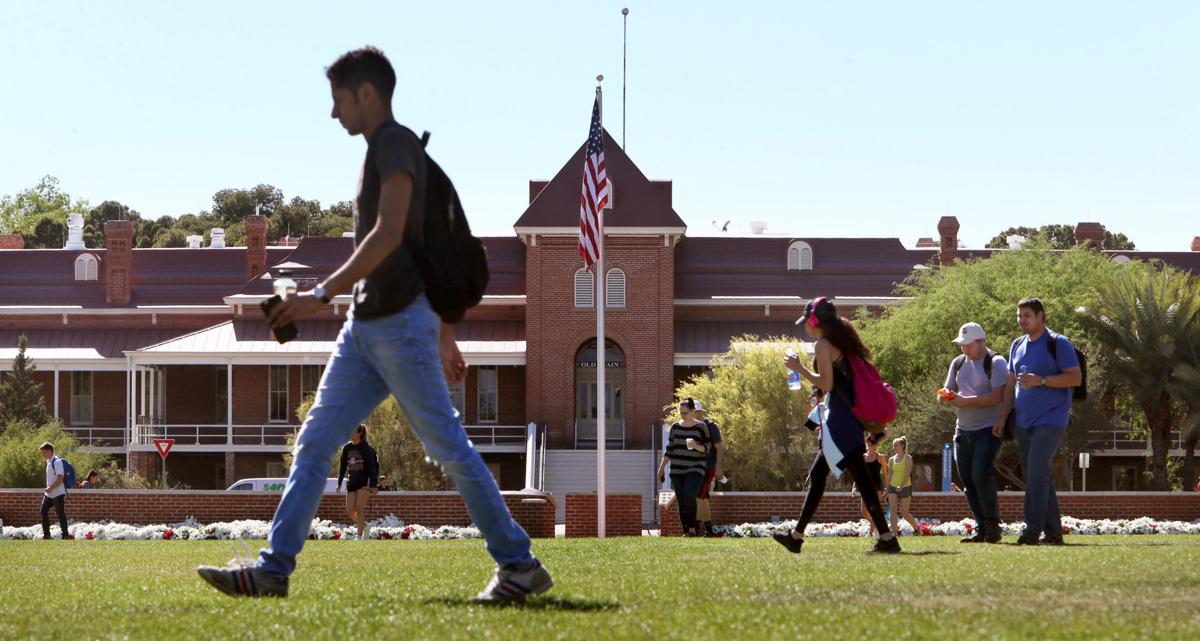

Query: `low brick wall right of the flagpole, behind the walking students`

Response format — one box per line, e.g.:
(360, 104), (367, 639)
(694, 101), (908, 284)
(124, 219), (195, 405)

(659, 492), (1200, 537)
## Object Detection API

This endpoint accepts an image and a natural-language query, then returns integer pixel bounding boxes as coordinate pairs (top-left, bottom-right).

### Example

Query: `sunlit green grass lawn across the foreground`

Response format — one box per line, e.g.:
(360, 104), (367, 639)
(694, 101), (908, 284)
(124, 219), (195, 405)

(0, 535), (1200, 641)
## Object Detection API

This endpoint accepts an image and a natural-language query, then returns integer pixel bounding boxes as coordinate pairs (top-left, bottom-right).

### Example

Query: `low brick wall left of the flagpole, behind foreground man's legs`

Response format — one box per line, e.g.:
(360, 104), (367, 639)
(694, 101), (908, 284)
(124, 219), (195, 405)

(0, 490), (554, 538)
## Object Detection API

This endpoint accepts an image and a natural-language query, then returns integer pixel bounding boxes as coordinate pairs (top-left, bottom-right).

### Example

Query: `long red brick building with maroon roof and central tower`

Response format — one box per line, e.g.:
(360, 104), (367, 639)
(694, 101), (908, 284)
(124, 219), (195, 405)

(0, 136), (1200, 510)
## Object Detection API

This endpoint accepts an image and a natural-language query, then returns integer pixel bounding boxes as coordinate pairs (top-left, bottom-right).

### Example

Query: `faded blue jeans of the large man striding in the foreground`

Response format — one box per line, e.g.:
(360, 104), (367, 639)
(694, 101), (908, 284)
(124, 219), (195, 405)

(257, 295), (533, 575)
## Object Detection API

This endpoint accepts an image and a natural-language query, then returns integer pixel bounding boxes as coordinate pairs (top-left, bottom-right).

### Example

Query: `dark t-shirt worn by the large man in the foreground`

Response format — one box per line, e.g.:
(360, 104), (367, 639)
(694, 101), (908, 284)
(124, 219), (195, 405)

(354, 120), (426, 319)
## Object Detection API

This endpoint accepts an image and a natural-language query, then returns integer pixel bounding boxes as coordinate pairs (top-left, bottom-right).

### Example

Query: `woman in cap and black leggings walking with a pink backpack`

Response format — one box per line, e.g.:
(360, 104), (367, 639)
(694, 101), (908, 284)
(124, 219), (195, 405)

(774, 296), (900, 553)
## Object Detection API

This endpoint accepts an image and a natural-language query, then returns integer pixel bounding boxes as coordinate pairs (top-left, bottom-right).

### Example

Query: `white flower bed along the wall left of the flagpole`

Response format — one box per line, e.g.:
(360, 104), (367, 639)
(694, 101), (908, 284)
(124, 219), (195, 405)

(0, 514), (482, 540)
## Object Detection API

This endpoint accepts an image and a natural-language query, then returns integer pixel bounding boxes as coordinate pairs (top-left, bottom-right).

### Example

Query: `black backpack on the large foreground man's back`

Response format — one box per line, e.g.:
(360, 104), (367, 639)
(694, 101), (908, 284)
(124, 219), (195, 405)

(413, 131), (488, 325)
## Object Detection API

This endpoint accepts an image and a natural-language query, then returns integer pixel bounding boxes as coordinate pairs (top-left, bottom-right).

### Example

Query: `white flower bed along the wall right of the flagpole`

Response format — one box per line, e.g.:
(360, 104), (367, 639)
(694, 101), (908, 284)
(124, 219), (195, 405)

(715, 516), (1200, 538)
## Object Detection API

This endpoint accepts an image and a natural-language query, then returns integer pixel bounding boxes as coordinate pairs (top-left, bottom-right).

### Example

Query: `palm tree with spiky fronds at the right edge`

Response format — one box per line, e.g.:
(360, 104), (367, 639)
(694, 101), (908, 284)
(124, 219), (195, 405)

(1076, 263), (1200, 491)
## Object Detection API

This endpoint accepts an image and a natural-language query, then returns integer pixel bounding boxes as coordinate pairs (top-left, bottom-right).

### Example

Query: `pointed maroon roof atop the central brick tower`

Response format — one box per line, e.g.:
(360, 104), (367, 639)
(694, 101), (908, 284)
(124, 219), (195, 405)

(514, 130), (686, 230)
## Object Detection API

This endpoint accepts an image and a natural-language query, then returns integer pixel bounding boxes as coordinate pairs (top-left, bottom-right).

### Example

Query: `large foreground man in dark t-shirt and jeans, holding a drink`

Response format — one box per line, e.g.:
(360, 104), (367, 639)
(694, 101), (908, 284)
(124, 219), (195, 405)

(198, 47), (553, 603)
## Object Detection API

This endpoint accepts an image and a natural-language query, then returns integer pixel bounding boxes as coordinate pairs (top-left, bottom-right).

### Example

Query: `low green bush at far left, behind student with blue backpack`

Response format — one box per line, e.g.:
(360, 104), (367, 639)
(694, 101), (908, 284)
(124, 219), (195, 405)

(0, 420), (108, 487)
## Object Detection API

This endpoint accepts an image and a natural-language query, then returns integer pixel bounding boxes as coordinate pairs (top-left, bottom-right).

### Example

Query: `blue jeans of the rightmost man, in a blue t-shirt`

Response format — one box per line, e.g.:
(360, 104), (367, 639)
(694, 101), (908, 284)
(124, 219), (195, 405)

(1014, 425), (1067, 537)
